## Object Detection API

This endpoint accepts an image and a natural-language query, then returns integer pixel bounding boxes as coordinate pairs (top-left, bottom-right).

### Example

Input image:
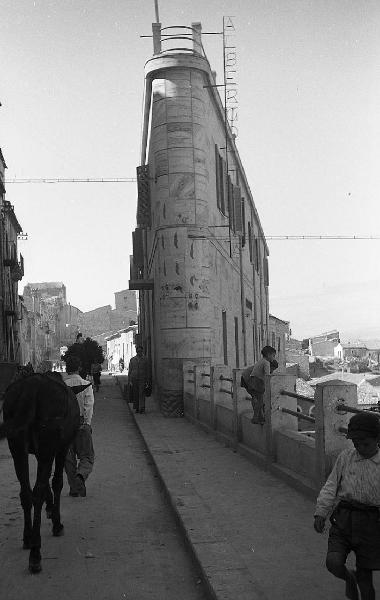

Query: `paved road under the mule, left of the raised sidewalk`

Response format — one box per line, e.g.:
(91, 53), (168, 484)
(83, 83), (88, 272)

(0, 376), (205, 600)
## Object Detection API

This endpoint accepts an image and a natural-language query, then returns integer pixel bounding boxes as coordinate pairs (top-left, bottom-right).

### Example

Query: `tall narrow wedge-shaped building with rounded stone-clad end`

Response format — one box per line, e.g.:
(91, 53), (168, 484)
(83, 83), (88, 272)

(130, 24), (269, 416)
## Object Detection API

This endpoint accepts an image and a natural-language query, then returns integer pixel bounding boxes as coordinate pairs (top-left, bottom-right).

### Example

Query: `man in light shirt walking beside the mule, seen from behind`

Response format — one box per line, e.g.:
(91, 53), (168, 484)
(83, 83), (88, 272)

(62, 355), (95, 497)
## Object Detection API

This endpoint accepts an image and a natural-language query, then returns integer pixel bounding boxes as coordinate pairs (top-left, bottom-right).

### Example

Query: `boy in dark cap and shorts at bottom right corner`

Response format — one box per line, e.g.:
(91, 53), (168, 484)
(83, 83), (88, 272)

(314, 412), (380, 600)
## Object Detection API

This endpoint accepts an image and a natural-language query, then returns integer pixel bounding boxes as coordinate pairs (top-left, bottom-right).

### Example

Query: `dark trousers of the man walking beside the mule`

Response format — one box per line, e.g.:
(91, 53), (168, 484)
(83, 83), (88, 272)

(65, 425), (95, 491)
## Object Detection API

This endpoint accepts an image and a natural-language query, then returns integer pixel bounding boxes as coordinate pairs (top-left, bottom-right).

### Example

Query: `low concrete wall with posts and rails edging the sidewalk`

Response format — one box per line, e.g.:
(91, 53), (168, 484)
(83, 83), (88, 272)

(183, 361), (359, 495)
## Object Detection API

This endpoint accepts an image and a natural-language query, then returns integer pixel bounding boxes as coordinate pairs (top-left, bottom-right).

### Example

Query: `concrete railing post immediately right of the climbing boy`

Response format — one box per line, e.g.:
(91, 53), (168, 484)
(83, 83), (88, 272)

(264, 373), (298, 462)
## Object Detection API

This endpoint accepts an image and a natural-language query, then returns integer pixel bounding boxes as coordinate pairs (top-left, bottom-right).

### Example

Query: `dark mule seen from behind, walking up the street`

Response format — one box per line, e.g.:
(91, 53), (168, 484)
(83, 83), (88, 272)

(0, 373), (83, 573)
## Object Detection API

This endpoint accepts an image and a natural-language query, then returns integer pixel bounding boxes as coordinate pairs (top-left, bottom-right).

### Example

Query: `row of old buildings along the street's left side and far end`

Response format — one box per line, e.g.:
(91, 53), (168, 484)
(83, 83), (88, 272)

(0, 149), (137, 395)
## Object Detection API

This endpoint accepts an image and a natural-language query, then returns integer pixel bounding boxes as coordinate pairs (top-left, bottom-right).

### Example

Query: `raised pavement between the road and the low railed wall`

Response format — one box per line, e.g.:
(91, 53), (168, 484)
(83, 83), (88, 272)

(119, 378), (379, 600)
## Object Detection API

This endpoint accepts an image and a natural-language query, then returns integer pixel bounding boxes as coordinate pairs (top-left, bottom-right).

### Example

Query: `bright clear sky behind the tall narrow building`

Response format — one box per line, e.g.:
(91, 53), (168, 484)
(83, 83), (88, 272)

(0, 0), (380, 338)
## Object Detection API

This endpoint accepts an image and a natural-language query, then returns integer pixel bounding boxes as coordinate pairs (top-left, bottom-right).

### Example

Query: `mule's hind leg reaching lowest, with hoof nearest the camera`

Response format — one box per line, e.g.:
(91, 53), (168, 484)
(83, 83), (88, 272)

(29, 456), (54, 573)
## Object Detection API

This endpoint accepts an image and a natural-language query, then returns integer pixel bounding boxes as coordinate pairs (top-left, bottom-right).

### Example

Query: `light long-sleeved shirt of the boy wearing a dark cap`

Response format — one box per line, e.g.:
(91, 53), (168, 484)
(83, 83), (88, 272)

(314, 448), (380, 518)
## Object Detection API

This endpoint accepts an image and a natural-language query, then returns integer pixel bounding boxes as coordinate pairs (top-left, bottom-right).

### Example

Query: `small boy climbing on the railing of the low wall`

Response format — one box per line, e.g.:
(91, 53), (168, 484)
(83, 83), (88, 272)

(241, 346), (278, 425)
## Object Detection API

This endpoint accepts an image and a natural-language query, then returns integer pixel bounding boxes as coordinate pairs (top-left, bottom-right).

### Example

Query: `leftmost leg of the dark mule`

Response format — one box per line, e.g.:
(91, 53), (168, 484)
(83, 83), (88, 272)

(8, 439), (33, 550)
